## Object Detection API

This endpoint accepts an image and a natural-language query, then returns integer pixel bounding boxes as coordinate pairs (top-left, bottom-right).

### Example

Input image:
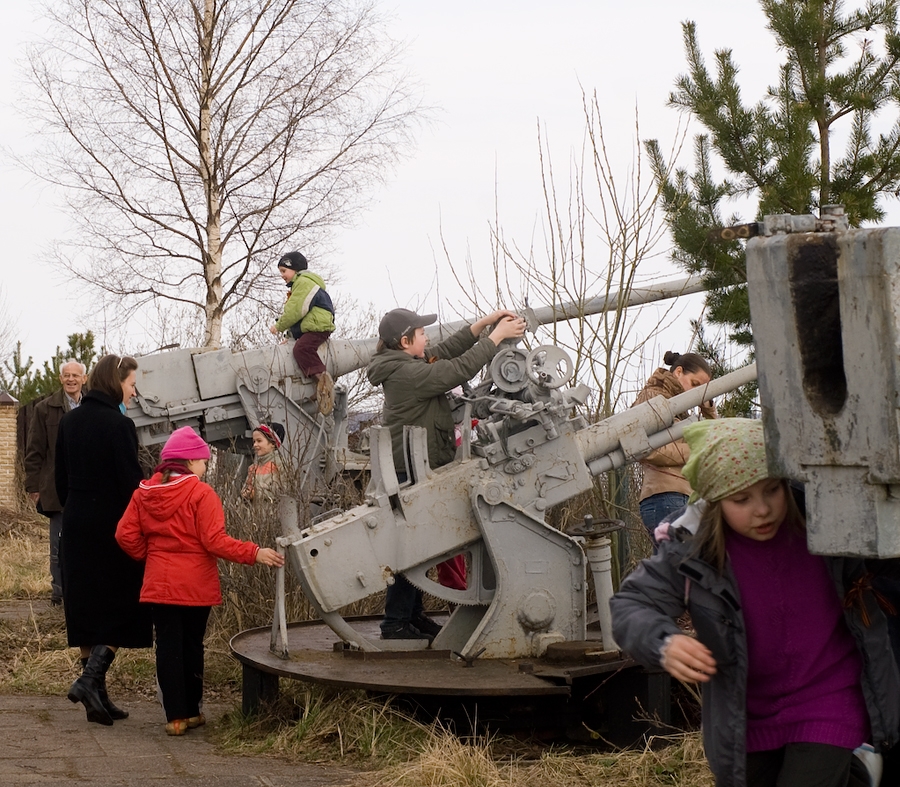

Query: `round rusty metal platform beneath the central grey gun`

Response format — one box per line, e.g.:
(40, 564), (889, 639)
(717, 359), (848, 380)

(230, 614), (670, 746)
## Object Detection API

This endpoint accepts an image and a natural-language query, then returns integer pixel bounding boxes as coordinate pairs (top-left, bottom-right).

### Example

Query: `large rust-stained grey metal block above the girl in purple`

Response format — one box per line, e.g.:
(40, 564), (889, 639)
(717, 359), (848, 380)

(747, 207), (900, 558)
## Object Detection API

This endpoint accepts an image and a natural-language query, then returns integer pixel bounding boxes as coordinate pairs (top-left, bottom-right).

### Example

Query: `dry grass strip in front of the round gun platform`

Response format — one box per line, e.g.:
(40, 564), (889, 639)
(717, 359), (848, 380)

(217, 683), (713, 787)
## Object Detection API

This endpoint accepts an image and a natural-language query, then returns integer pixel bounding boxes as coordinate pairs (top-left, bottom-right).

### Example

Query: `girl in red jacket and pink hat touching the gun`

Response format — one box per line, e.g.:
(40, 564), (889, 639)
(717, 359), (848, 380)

(116, 426), (284, 735)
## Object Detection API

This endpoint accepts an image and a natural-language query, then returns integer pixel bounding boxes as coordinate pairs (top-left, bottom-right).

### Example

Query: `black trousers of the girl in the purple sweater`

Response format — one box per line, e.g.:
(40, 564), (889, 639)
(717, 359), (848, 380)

(747, 743), (869, 787)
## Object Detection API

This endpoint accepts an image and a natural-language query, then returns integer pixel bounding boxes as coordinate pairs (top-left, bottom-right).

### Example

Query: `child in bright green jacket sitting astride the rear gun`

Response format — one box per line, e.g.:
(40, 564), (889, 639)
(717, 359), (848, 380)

(269, 251), (334, 415)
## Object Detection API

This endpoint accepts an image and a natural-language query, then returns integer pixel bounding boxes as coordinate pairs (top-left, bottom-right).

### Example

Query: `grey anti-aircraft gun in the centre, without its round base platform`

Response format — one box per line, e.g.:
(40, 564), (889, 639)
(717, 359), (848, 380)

(279, 358), (756, 659)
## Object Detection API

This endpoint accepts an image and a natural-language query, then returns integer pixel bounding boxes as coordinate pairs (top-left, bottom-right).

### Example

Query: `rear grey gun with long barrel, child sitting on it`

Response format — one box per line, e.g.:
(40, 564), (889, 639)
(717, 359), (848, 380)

(128, 277), (702, 491)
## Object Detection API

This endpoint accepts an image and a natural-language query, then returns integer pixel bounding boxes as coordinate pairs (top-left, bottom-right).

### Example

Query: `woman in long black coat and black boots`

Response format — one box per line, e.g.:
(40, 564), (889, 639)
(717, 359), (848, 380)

(56, 355), (152, 725)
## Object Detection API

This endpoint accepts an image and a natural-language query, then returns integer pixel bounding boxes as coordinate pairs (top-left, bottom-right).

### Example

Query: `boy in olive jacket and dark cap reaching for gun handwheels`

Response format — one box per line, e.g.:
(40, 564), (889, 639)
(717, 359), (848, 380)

(368, 309), (525, 640)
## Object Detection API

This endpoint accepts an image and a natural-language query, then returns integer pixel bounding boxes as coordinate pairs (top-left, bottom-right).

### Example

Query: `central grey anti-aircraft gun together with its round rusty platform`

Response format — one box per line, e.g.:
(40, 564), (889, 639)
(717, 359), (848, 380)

(221, 330), (756, 745)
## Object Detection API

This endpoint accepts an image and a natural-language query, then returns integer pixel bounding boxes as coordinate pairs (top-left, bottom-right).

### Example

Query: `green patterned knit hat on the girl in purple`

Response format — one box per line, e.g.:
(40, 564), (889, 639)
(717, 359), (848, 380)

(682, 418), (769, 503)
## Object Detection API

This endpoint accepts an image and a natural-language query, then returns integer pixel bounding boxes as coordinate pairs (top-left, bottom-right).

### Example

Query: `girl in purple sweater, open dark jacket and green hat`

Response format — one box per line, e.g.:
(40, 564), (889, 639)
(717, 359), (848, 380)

(611, 418), (900, 787)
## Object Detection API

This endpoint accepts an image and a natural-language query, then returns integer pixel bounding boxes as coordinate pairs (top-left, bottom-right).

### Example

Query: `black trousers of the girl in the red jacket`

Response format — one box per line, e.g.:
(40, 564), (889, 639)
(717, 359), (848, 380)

(152, 604), (210, 721)
